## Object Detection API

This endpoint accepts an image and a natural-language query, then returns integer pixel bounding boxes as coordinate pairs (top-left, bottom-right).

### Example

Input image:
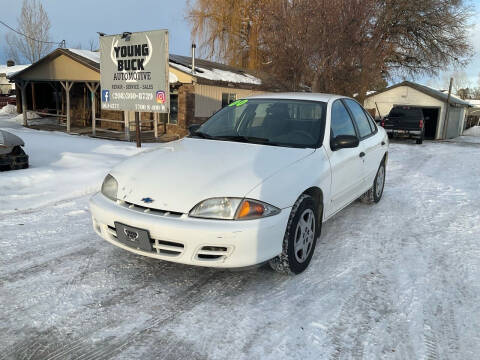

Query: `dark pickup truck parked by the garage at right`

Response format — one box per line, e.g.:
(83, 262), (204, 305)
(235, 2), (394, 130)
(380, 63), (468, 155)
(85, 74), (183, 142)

(380, 106), (425, 144)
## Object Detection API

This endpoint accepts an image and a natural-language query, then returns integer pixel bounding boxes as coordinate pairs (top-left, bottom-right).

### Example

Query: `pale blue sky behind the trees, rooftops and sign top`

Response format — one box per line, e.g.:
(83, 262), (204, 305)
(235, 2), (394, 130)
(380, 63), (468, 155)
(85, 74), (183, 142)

(0, 0), (480, 87)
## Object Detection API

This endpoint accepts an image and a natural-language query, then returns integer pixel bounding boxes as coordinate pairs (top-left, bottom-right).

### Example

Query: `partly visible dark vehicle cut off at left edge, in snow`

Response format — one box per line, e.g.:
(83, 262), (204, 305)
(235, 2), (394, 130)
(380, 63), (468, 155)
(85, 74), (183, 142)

(0, 130), (28, 171)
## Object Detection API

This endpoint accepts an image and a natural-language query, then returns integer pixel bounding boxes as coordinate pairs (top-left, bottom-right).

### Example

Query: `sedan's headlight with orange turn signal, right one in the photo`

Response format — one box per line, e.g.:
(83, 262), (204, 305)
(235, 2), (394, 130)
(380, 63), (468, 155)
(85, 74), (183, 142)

(189, 198), (280, 220)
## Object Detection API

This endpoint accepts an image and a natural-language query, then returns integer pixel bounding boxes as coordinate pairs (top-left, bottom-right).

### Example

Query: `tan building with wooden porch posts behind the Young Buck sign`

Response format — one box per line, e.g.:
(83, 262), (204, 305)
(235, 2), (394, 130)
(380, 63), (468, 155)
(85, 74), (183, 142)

(9, 48), (274, 139)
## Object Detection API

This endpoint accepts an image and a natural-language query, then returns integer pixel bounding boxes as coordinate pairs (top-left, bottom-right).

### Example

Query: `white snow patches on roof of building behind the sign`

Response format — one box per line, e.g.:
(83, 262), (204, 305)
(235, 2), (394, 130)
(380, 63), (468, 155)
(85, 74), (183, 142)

(68, 49), (262, 85)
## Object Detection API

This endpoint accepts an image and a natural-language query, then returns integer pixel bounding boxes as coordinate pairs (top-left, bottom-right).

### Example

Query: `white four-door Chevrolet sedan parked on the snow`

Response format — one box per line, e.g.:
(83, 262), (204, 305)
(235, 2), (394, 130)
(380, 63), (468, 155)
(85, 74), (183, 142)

(90, 93), (388, 274)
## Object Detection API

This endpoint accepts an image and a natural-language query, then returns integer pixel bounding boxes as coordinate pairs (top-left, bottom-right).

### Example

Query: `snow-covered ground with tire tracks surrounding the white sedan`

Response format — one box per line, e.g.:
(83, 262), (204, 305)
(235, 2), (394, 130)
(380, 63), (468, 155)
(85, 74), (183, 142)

(0, 113), (480, 360)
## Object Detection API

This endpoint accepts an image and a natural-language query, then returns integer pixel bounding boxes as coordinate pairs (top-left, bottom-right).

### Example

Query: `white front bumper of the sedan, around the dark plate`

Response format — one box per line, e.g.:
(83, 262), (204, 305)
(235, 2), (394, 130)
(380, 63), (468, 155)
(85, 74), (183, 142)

(90, 193), (291, 268)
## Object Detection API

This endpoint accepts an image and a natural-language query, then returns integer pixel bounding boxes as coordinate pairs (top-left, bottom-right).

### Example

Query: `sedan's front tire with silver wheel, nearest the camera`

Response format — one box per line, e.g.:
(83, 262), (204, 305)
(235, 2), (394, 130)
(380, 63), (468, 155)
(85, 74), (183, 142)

(269, 195), (322, 275)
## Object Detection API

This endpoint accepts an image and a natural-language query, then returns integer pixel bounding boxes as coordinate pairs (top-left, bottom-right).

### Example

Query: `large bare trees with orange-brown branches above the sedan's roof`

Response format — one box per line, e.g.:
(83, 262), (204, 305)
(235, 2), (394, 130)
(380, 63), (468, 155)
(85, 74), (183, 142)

(188, 0), (471, 95)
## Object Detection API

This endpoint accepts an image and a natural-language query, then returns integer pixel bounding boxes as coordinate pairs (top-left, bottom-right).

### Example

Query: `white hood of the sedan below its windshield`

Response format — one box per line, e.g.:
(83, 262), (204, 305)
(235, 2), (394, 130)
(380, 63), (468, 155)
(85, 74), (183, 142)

(111, 138), (314, 213)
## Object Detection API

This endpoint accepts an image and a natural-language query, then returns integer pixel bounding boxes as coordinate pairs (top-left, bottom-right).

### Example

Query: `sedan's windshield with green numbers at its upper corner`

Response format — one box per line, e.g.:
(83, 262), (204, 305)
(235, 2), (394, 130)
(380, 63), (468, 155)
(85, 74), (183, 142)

(193, 99), (327, 148)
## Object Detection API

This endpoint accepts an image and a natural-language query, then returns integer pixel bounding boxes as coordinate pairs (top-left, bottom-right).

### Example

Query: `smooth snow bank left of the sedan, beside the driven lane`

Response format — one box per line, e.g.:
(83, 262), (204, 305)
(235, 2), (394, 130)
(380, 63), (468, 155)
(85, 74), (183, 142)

(0, 119), (152, 214)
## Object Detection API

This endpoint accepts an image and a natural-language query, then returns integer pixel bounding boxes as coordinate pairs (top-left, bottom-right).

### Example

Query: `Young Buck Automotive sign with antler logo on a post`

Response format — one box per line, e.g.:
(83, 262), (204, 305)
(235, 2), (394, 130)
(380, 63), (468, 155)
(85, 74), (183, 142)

(100, 30), (170, 113)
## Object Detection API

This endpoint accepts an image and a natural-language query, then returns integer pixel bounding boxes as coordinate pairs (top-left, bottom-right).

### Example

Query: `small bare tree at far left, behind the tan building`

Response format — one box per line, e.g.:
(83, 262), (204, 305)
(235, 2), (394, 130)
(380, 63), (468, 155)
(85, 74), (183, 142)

(5, 0), (53, 63)
